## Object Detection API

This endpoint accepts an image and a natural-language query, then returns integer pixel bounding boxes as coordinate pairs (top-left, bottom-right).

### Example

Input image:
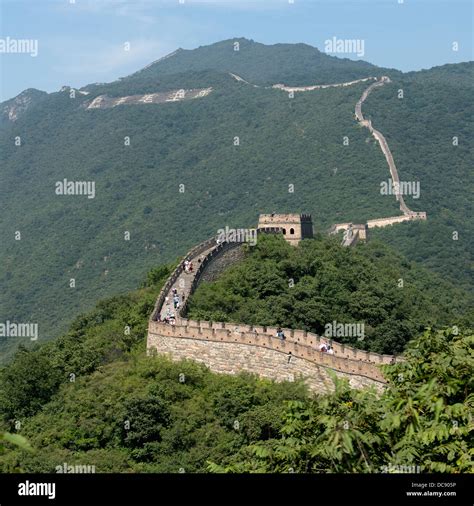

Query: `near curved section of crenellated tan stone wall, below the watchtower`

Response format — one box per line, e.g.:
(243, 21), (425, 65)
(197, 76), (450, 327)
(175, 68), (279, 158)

(147, 233), (395, 391)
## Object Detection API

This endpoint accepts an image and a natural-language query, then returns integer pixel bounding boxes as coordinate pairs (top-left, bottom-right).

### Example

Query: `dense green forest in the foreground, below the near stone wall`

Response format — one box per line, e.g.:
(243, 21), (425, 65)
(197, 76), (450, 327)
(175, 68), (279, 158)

(0, 260), (474, 473)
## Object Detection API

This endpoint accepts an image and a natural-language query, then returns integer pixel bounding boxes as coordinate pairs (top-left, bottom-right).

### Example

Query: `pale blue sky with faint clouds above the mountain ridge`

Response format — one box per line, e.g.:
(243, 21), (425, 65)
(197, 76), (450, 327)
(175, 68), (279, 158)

(0, 0), (473, 101)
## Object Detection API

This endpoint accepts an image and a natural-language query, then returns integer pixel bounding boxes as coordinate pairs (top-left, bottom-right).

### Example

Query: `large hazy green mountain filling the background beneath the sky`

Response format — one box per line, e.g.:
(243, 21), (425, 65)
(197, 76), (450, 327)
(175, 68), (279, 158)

(0, 39), (473, 359)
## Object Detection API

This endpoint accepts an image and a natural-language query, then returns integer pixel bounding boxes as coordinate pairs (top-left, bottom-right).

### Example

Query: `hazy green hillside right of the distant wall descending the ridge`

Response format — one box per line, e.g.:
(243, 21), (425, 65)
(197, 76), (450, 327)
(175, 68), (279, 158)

(365, 63), (474, 290)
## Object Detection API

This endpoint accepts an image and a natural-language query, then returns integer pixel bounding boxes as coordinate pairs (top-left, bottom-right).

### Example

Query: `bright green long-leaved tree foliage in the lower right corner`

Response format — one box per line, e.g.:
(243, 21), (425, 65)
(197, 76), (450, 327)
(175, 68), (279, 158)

(209, 329), (474, 473)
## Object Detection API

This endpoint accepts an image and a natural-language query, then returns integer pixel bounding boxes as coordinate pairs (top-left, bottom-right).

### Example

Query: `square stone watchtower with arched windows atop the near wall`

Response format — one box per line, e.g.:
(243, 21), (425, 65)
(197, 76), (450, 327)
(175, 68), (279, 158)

(258, 213), (313, 246)
